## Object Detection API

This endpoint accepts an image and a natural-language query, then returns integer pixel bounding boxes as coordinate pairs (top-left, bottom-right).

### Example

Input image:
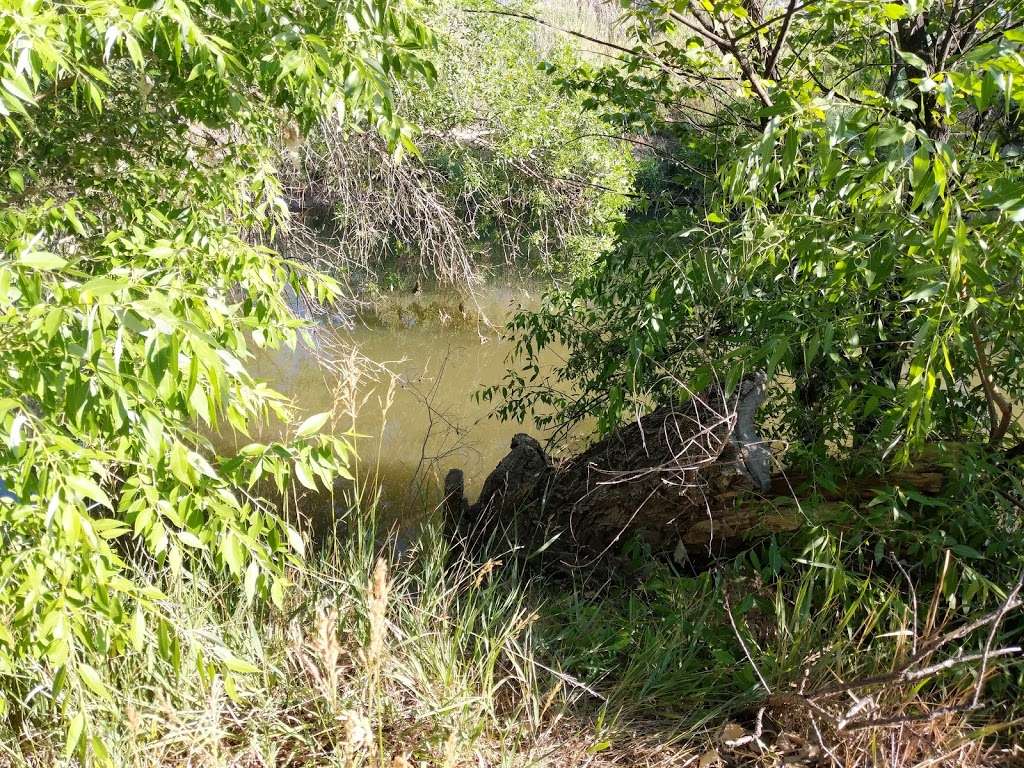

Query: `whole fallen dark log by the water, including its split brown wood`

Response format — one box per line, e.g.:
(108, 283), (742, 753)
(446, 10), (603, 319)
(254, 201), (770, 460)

(444, 376), (944, 565)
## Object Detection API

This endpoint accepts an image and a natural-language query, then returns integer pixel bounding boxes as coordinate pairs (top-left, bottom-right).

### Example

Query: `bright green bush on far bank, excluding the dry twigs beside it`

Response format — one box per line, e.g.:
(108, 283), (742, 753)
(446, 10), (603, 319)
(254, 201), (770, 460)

(409, 2), (635, 269)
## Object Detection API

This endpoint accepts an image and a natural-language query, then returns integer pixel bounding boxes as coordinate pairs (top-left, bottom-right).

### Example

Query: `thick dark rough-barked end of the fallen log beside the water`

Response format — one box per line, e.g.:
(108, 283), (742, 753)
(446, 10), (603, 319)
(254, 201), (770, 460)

(447, 377), (771, 563)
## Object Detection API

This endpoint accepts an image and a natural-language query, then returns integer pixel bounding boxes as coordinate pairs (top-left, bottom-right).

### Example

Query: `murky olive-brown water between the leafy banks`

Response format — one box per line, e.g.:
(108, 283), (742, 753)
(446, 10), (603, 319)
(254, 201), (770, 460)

(235, 286), (581, 518)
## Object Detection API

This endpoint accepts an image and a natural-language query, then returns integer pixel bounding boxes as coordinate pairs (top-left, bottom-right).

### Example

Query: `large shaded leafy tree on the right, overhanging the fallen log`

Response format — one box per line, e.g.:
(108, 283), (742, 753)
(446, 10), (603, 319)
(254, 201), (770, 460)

(488, 2), (1024, 459)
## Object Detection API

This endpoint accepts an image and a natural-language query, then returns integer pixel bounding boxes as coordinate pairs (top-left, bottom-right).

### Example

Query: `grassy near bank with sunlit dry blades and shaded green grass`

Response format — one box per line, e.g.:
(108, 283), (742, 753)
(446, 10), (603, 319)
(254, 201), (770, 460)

(8, 489), (1020, 768)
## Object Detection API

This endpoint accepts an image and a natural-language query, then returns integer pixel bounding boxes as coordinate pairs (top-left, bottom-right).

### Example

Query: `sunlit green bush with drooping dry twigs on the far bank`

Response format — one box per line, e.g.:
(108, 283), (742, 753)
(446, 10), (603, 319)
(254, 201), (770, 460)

(293, 0), (636, 283)
